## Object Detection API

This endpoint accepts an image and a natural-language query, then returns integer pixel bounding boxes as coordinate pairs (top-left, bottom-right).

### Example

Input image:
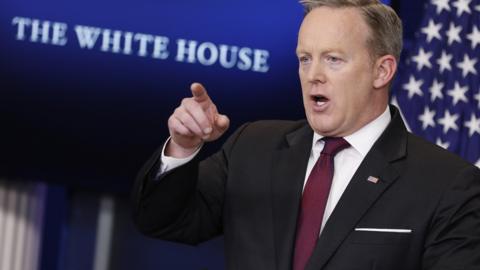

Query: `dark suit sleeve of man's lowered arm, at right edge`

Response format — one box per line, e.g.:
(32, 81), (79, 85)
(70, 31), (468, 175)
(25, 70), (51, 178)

(422, 166), (480, 270)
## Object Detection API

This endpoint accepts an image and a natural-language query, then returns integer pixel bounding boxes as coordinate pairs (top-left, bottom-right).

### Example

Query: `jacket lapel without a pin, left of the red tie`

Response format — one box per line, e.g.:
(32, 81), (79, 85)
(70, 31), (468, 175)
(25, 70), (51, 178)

(271, 125), (313, 270)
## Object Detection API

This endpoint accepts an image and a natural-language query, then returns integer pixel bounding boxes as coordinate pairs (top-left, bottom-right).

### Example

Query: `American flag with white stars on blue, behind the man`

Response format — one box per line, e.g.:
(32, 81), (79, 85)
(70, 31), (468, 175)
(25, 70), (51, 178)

(392, 0), (480, 167)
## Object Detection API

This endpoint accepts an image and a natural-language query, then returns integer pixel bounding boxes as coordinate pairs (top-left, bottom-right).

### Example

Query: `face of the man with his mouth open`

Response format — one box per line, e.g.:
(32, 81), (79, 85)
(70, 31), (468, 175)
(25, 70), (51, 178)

(297, 7), (387, 137)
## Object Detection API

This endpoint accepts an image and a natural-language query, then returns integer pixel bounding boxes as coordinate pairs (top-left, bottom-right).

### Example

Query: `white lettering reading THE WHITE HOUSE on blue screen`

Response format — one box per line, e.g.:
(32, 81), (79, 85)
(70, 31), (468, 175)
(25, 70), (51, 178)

(12, 16), (270, 73)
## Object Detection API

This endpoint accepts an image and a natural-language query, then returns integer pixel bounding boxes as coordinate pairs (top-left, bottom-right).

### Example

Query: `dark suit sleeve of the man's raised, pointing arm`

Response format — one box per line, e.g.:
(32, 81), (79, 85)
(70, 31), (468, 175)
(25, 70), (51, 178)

(132, 125), (251, 244)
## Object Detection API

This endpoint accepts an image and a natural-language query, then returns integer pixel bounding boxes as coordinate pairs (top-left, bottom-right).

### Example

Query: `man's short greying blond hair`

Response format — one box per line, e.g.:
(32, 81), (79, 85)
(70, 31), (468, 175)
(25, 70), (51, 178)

(300, 0), (403, 61)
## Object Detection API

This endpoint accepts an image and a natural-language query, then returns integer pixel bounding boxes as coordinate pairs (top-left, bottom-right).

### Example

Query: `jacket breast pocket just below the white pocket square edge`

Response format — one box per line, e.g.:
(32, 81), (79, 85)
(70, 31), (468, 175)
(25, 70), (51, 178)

(348, 231), (412, 245)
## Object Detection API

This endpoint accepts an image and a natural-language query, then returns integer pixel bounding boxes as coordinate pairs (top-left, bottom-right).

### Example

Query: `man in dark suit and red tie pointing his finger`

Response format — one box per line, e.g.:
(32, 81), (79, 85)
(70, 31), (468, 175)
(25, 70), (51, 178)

(134, 0), (480, 270)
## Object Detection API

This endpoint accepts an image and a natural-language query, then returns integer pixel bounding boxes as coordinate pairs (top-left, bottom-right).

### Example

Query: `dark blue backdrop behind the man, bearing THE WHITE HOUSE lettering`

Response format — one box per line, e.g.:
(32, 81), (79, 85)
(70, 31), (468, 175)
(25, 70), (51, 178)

(0, 0), (436, 270)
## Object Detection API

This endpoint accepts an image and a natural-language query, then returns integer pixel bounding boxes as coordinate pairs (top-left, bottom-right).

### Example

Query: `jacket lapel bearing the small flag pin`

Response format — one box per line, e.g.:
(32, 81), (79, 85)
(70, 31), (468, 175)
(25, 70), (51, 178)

(306, 107), (407, 270)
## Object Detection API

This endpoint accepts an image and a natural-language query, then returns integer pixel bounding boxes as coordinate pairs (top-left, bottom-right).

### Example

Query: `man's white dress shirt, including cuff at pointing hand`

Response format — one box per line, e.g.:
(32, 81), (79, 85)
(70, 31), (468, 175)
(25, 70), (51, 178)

(157, 106), (391, 232)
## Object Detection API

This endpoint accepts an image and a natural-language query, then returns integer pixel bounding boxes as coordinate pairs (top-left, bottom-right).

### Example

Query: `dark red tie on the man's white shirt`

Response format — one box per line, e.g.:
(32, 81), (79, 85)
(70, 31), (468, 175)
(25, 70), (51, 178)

(293, 137), (349, 270)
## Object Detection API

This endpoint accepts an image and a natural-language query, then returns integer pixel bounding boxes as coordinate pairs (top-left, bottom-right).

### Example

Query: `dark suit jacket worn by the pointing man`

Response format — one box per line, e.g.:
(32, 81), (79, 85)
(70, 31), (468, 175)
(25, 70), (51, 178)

(133, 107), (480, 270)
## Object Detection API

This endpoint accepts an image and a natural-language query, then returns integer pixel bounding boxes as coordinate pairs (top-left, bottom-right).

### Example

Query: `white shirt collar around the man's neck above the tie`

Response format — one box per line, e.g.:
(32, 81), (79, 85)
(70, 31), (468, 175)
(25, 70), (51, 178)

(312, 106), (392, 156)
